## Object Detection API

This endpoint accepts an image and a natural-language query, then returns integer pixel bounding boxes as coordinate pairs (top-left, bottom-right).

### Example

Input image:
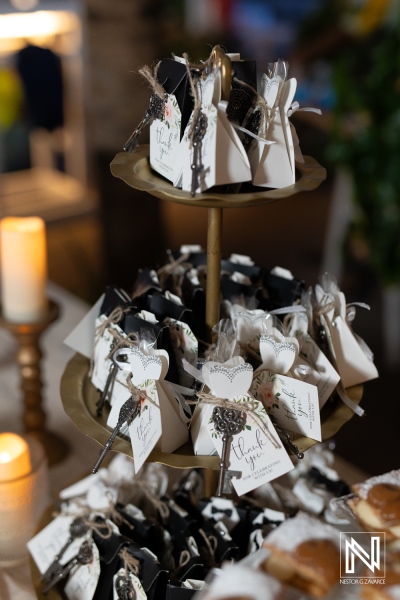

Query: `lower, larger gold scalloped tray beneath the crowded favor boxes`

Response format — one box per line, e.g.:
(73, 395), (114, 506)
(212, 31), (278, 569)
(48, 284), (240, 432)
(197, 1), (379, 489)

(61, 354), (363, 470)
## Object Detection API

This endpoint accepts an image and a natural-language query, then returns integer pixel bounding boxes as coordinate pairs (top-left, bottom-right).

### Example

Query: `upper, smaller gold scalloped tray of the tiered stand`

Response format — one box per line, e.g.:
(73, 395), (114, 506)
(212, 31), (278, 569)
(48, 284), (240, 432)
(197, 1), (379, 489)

(110, 144), (326, 208)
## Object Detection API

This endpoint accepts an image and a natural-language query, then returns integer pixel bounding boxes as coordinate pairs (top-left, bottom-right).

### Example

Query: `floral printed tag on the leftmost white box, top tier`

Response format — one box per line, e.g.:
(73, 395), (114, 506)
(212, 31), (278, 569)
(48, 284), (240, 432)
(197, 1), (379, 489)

(150, 94), (182, 181)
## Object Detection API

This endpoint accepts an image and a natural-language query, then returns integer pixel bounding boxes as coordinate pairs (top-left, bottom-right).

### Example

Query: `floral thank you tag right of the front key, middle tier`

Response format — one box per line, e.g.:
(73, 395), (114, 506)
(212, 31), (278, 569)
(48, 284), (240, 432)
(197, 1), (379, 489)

(250, 371), (321, 442)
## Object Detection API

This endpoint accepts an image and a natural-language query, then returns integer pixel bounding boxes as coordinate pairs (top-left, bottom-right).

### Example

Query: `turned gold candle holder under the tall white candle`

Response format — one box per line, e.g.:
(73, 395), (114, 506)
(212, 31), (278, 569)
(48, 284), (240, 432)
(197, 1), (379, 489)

(0, 300), (68, 466)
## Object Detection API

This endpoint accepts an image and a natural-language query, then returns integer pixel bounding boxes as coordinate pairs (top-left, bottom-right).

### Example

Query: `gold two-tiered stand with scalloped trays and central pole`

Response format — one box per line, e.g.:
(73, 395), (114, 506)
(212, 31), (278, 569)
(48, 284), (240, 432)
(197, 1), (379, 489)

(61, 145), (362, 470)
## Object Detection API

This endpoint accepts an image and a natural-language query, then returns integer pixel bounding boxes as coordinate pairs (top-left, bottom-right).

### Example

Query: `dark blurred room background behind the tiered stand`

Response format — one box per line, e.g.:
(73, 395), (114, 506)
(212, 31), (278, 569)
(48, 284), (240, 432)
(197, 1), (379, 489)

(0, 0), (400, 474)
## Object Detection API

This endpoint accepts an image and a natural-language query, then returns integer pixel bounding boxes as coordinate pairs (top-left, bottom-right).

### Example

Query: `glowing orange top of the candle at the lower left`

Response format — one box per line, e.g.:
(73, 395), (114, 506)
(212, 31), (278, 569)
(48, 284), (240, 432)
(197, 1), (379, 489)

(0, 433), (31, 483)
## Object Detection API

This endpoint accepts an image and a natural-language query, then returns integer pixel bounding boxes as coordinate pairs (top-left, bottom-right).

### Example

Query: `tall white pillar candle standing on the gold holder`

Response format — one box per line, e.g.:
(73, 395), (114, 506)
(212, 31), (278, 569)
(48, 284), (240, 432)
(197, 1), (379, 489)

(0, 217), (47, 323)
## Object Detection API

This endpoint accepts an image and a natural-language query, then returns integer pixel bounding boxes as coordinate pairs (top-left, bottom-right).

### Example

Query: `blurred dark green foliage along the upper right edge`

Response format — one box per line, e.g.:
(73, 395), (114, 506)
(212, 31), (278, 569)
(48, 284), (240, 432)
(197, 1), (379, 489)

(328, 22), (400, 286)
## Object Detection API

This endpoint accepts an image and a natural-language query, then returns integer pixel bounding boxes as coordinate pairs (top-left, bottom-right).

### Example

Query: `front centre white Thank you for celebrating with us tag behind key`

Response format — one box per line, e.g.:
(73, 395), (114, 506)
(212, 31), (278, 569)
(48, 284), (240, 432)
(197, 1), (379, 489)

(207, 395), (293, 496)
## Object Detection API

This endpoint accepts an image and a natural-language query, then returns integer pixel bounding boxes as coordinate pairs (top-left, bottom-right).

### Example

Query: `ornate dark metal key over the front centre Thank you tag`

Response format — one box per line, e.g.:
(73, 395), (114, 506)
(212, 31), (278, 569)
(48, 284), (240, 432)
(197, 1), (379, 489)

(211, 406), (246, 496)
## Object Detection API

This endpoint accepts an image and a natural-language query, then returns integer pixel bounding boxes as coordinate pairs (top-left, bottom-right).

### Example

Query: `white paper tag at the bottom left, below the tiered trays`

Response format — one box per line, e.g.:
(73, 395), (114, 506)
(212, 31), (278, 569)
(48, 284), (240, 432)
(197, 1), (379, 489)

(27, 515), (83, 573)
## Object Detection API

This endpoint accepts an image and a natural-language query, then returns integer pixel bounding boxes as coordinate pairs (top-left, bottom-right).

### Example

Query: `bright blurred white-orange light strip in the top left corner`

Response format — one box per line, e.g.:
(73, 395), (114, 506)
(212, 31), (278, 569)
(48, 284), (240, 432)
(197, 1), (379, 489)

(0, 10), (79, 40)
